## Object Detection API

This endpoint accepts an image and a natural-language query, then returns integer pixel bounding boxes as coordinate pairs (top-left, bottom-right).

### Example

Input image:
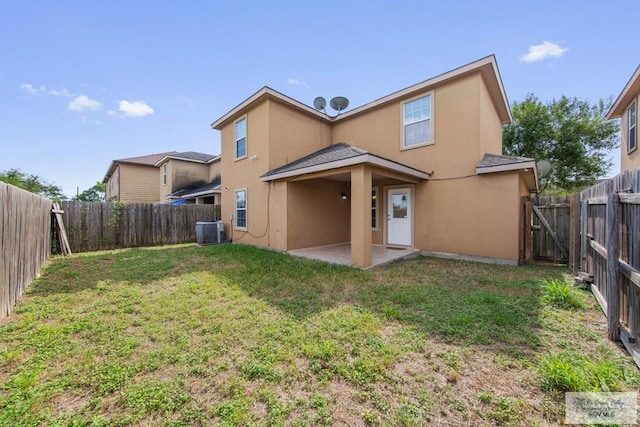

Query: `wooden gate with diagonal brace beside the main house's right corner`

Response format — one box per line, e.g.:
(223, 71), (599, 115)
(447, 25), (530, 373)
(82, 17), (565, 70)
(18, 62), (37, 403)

(531, 196), (571, 264)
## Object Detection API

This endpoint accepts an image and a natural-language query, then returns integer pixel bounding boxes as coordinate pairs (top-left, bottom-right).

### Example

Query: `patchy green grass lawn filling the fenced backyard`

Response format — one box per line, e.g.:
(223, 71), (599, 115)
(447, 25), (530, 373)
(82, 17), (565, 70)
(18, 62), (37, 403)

(0, 245), (640, 426)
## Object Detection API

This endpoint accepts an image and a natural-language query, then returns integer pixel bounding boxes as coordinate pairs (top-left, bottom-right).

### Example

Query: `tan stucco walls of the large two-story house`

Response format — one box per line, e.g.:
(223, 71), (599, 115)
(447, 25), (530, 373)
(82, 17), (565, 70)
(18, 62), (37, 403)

(221, 73), (521, 261)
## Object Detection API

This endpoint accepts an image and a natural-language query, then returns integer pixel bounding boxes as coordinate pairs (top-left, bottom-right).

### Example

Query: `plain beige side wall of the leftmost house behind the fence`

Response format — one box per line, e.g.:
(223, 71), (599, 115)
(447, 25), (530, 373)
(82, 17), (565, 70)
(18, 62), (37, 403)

(119, 163), (160, 203)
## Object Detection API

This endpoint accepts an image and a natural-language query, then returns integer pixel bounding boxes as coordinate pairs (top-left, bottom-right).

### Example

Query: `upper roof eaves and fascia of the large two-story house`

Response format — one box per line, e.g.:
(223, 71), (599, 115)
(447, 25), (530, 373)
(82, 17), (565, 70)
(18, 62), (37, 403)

(211, 55), (512, 130)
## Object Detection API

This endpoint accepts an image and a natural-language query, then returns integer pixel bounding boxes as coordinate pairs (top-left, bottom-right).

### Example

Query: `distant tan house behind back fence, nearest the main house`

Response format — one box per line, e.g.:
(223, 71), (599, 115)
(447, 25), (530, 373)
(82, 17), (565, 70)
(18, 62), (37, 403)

(155, 151), (221, 204)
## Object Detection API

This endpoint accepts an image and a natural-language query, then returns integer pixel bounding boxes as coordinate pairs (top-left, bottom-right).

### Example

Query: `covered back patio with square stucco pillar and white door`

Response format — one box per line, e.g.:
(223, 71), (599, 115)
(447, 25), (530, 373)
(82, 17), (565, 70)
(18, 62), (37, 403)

(261, 143), (429, 268)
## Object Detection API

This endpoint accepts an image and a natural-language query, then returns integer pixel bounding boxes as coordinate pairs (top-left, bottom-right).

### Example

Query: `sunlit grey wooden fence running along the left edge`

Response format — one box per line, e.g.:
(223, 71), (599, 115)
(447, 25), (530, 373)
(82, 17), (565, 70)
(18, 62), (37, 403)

(0, 182), (51, 317)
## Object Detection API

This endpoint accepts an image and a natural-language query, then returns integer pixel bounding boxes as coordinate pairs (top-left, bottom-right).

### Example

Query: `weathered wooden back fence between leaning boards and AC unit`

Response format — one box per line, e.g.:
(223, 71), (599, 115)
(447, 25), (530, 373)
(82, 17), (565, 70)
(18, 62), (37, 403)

(60, 201), (220, 252)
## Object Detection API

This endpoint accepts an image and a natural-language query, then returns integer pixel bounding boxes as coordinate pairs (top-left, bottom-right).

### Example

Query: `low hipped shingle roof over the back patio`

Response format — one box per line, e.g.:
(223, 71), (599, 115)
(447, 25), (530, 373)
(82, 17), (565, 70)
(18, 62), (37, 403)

(260, 142), (431, 182)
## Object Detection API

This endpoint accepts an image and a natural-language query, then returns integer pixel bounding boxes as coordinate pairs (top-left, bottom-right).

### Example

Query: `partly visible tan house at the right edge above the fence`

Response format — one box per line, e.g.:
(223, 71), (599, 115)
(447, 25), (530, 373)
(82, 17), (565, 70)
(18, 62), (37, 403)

(607, 66), (640, 171)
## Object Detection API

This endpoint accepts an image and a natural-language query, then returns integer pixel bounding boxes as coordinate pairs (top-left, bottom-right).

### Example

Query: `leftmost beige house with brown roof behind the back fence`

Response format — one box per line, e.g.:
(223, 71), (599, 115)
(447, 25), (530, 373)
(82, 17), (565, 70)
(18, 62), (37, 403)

(102, 151), (175, 203)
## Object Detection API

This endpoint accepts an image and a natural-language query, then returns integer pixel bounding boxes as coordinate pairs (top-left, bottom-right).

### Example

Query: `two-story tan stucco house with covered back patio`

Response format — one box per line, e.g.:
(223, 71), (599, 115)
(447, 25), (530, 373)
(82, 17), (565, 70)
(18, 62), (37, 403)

(211, 56), (537, 267)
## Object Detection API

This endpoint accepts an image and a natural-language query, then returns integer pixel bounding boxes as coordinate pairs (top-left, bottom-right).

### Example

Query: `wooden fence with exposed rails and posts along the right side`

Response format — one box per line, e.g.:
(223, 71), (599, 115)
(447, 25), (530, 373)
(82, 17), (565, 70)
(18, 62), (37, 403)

(576, 169), (640, 366)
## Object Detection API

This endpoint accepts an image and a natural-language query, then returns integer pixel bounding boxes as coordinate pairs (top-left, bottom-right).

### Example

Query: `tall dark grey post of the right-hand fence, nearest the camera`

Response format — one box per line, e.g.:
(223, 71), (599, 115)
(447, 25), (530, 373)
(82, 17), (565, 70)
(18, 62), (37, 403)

(606, 192), (620, 341)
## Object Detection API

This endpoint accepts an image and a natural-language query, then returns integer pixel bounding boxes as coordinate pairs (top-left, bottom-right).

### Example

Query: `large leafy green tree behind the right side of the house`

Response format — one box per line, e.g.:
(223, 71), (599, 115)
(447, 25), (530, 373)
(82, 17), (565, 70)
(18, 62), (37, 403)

(502, 94), (620, 192)
